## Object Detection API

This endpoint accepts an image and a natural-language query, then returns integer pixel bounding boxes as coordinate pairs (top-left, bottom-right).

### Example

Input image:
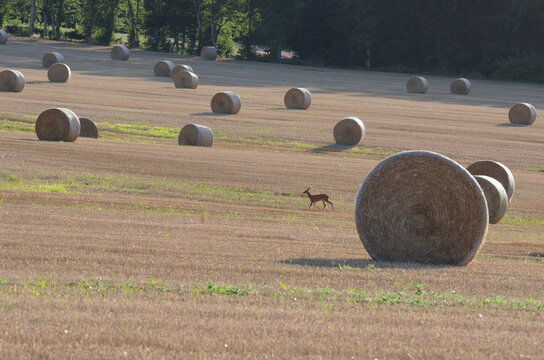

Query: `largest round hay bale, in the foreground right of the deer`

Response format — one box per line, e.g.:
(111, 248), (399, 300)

(355, 151), (488, 265)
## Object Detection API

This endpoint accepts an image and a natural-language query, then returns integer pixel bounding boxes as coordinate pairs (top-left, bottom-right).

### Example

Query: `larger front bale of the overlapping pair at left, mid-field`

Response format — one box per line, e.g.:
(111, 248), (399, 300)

(36, 108), (81, 142)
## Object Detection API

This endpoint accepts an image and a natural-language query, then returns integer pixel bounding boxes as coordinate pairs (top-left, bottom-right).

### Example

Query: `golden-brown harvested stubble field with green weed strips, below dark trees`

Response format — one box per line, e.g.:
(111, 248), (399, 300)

(0, 38), (544, 359)
